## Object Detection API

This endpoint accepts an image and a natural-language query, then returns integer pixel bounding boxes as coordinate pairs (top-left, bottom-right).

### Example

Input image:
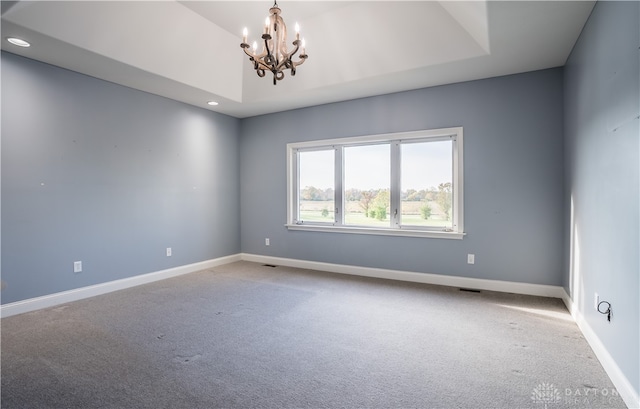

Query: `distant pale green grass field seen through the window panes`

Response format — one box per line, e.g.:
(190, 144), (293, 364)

(300, 201), (451, 227)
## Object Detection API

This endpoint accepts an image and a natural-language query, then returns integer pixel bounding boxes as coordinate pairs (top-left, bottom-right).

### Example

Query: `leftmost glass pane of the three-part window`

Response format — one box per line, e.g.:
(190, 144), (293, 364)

(298, 149), (336, 223)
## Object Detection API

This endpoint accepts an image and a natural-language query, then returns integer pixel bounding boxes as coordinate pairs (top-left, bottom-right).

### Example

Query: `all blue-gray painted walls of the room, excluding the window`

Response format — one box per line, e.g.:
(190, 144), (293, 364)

(1, 2), (640, 398)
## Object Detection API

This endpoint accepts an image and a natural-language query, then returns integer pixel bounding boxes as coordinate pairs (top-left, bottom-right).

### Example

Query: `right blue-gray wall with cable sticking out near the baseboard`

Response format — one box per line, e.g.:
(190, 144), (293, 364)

(563, 1), (640, 394)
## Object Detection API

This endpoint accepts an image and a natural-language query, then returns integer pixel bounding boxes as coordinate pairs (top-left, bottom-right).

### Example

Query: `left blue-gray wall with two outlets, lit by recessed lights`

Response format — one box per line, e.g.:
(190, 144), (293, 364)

(2, 52), (240, 303)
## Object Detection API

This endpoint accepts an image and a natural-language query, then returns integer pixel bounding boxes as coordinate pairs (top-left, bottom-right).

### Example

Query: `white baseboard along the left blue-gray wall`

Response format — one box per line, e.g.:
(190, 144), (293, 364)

(0, 254), (241, 318)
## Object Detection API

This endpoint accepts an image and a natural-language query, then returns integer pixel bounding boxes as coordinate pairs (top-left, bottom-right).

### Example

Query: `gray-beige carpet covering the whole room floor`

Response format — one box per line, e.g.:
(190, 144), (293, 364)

(1, 262), (625, 409)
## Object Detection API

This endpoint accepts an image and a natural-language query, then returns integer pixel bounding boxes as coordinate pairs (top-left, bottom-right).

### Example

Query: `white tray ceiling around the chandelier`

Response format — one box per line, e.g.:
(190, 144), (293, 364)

(1, 0), (595, 118)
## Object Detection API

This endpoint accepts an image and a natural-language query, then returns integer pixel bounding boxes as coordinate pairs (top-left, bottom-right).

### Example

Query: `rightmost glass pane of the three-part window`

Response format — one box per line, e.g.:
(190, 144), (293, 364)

(400, 141), (453, 229)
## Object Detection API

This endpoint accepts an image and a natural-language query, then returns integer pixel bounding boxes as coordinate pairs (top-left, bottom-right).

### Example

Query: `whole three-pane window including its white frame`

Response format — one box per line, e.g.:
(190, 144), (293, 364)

(287, 128), (464, 239)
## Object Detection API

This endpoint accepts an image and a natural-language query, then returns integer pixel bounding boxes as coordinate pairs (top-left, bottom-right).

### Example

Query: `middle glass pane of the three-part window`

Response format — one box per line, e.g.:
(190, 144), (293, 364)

(343, 143), (391, 227)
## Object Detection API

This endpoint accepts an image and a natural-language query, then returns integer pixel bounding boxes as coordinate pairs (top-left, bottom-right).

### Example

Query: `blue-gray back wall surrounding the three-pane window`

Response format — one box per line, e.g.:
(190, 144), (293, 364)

(240, 68), (563, 285)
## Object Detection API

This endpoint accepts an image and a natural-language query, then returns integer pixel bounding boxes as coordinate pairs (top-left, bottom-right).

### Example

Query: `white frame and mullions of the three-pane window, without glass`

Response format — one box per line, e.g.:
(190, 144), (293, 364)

(285, 127), (465, 239)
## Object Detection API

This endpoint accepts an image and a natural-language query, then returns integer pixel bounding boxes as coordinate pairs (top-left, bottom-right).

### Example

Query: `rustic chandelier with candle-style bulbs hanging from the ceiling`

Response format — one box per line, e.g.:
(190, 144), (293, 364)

(240, 1), (307, 85)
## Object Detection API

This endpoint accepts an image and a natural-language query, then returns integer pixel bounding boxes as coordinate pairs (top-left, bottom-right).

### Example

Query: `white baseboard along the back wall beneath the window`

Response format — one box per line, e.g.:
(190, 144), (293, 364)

(241, 253), (564, 298)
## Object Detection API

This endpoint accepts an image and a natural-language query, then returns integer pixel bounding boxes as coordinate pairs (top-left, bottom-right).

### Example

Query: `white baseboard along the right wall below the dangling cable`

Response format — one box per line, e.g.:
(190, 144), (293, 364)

(561, 288), (640, 409)
